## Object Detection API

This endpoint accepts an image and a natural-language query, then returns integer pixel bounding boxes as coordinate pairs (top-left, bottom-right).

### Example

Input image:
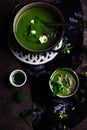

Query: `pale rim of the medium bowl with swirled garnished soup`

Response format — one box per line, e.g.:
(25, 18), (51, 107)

(49, 68), (80, 98)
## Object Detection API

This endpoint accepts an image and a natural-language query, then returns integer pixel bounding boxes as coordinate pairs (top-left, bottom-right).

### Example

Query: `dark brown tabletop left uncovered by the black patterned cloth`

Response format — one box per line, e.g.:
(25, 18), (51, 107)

(0, 0), (87, 130)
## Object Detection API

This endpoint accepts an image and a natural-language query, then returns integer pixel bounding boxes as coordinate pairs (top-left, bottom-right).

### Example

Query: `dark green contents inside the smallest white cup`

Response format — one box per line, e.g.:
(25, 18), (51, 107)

(12, 72), (25, 85)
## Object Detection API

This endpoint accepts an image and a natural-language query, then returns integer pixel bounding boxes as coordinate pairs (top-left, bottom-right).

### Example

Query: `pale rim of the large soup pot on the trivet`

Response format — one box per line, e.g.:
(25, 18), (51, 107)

(12, 2), (65, 53)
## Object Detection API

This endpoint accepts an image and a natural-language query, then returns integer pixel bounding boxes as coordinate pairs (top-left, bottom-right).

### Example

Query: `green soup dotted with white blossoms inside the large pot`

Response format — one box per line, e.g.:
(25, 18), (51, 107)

(15, 6), (60, 51)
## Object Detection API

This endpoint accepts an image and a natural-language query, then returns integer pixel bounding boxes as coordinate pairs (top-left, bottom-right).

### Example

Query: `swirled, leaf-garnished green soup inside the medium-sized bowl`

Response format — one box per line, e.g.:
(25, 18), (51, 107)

(51, 69), (77, 96)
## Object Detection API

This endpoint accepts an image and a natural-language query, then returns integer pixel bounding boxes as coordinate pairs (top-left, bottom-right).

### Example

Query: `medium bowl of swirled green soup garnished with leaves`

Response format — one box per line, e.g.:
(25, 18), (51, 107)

(49, 68), (79, 98)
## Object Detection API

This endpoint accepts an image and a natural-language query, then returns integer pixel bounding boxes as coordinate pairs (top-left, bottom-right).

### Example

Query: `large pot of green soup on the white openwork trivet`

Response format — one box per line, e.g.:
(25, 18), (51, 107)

(13, 2), (65, 52)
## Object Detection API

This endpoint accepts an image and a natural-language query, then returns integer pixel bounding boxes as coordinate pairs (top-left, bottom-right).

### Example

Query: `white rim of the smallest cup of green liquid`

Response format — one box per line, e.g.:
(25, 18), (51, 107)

(9, 69), (27, 87)
